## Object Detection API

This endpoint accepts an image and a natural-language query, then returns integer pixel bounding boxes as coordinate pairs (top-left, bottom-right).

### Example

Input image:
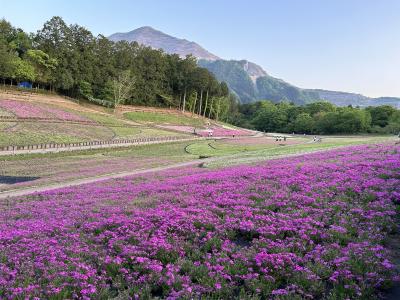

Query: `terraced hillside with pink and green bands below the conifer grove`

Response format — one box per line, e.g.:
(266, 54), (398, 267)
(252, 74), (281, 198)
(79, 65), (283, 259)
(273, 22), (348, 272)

(0, 90), (254, 147)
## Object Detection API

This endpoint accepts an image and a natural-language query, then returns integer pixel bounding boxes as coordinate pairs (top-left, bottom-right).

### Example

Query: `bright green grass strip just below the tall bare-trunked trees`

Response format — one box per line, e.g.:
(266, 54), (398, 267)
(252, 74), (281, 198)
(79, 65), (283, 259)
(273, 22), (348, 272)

(124, 112), (204, 127)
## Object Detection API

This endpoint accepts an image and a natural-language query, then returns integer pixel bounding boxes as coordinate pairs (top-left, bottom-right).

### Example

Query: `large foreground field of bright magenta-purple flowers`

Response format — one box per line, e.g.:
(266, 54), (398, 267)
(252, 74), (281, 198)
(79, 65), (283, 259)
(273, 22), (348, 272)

(0, 145), (400, 299)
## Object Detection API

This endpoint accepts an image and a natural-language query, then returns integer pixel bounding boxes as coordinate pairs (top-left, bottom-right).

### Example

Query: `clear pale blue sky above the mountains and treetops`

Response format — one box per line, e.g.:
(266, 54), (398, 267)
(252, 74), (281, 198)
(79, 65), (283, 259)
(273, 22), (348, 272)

(0, 0), (400, 96)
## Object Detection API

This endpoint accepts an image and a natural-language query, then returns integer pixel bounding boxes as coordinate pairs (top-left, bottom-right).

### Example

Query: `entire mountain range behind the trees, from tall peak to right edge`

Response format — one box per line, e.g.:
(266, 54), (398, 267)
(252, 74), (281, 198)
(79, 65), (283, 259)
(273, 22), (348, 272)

(109, 26), (400, 108)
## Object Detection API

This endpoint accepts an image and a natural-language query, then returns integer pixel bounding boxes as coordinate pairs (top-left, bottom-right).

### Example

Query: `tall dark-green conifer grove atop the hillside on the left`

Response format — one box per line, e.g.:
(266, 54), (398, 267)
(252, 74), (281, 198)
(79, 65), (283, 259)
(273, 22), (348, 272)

(0, 17), (237, 119)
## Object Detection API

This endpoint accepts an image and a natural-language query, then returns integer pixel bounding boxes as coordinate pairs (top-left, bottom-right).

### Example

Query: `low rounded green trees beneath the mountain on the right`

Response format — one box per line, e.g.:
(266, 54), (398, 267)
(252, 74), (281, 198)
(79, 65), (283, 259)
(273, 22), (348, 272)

(231, 101), (400, 134)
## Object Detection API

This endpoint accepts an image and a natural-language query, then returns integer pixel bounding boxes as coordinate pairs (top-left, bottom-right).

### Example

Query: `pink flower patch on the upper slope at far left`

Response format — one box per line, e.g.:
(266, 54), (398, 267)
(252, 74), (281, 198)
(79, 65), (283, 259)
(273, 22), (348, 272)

(0, 99), (88, 121)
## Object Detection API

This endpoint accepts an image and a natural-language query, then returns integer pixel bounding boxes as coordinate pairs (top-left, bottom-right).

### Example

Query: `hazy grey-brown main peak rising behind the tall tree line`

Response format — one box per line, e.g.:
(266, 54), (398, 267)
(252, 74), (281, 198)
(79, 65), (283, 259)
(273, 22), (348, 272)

(108, 26), (220, 60)
